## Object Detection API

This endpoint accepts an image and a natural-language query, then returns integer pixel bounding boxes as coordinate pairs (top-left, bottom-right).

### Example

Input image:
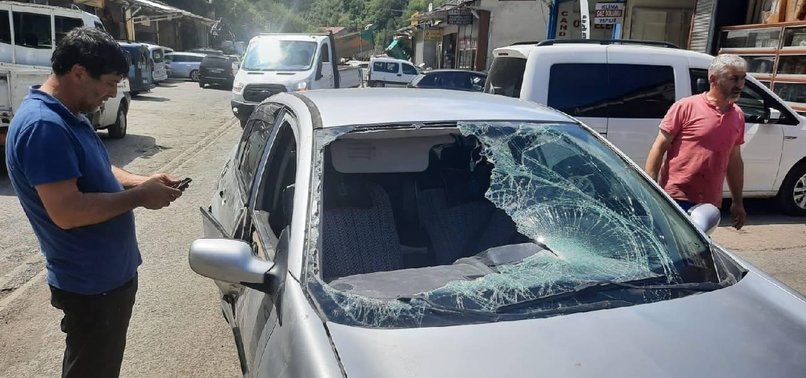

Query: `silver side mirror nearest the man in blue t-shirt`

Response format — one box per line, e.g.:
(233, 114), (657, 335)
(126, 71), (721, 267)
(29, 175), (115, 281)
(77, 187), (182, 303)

(188, 239), (276, 286)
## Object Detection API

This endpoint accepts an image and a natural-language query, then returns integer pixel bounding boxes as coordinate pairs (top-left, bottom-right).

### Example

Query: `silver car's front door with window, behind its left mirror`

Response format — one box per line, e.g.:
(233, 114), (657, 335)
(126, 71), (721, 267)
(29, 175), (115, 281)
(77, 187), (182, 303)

(233, 113), (298, 371)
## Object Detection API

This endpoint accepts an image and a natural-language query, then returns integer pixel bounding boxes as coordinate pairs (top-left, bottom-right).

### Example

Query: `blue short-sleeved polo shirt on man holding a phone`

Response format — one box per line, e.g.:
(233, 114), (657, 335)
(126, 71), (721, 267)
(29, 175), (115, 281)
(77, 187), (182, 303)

(6, 87), (142, 294)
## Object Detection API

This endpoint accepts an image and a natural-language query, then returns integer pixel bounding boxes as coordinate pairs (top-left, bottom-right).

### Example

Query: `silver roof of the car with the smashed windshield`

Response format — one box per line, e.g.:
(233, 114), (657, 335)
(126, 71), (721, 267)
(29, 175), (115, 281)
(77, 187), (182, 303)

(288, 88), (577, 128)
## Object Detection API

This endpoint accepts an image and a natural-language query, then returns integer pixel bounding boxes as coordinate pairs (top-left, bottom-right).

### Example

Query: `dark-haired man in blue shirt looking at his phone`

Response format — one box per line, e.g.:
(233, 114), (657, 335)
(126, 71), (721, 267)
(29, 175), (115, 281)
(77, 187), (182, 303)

(6, 28), (182, 377)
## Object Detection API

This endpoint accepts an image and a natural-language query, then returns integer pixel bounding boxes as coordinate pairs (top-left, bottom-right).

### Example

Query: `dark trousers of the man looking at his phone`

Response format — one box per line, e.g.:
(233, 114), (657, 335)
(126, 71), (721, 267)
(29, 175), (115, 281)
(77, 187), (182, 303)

(50, 276), (137, 377)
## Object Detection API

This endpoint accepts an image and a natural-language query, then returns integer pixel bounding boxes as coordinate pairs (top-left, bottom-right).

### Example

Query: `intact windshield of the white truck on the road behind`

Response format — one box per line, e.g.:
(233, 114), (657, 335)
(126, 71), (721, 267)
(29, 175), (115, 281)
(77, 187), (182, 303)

(242, 38), (316, 71)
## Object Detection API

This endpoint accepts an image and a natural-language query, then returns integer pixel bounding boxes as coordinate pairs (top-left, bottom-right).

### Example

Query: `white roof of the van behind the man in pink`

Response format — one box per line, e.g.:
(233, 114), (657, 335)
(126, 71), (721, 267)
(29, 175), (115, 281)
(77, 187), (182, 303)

(493, 43), (714, 66)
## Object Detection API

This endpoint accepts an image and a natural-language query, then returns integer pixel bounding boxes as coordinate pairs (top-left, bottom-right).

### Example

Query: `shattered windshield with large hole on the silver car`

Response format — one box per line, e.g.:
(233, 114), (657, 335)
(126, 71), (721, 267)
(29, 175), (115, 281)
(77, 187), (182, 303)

(306, 122), (719, 328)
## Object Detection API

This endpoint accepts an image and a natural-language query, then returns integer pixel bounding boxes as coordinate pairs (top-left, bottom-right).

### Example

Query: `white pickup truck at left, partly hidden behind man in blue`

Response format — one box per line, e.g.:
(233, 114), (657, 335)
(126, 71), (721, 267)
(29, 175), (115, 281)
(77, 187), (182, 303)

(0, 1), (131, 170)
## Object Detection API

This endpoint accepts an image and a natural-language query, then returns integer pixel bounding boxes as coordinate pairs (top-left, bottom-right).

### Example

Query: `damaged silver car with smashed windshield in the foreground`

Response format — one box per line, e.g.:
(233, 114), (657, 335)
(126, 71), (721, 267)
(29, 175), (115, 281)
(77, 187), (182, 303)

(189, 88), (806, 378)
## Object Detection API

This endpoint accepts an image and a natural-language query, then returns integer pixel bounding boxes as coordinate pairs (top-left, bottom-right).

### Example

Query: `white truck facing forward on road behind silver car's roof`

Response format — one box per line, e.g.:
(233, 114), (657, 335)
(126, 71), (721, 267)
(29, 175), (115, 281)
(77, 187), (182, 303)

(231, 34), (363, 126)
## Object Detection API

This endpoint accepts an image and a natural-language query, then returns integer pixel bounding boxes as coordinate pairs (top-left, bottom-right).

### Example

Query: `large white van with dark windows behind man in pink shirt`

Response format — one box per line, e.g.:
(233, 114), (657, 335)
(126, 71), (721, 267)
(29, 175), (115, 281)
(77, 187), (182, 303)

(485, 40), (806, 215)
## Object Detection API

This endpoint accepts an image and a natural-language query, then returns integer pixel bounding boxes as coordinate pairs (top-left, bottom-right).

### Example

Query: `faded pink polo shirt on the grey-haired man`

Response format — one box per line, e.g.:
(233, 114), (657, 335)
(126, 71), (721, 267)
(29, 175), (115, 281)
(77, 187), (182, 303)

(660, 93), (744, 207)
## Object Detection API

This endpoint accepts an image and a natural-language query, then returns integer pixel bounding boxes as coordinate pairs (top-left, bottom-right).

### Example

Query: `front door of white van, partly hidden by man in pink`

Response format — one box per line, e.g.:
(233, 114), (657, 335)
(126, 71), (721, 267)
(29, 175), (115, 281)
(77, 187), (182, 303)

(691, 69), (791, 193)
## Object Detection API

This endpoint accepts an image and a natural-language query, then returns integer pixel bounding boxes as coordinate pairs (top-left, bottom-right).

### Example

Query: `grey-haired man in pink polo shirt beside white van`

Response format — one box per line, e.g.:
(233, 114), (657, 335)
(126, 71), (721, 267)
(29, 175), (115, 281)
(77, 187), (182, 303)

(644, 54), (747, 230)
